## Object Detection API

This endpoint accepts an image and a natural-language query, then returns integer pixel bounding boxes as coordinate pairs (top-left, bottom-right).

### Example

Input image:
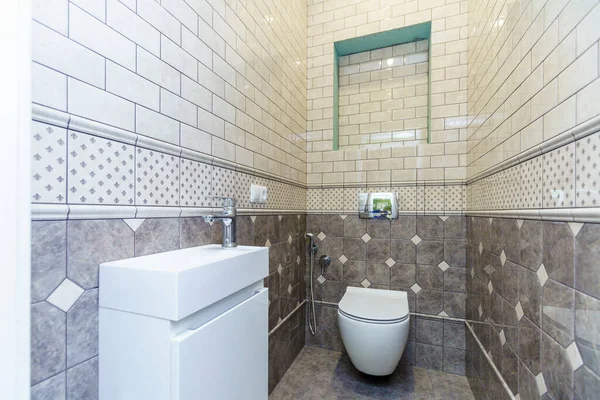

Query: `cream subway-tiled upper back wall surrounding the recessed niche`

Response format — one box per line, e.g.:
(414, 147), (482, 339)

(306, 0), (469, 187)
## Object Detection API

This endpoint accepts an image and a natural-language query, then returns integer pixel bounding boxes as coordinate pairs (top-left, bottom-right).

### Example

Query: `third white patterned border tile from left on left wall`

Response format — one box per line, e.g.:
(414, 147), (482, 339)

(135, 147), (179, 206)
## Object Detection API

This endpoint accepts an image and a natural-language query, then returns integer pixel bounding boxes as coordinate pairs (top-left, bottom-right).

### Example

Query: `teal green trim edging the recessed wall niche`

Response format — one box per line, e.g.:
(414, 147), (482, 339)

(333, 22), (431, 150)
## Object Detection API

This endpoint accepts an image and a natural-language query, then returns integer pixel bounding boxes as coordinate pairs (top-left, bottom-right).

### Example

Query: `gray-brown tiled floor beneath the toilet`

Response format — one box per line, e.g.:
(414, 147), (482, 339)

(269, 346), (474, 400)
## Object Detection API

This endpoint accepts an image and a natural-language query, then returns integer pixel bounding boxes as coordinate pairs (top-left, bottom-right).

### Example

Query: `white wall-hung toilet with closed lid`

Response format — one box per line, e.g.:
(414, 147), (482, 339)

(338, 286), (410, 376)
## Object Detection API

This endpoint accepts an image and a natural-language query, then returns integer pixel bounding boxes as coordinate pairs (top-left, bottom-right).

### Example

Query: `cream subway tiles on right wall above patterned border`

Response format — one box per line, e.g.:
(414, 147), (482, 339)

(467, 0), (600, 180)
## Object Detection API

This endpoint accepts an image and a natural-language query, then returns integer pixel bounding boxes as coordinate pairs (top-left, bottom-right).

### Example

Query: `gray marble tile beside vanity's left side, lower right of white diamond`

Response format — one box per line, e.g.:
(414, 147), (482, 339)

(67, 289), (98, 368)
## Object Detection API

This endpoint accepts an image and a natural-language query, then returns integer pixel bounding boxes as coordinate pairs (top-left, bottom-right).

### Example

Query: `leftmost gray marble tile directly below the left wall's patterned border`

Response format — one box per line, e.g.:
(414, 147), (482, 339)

(31, 221), (67, 303)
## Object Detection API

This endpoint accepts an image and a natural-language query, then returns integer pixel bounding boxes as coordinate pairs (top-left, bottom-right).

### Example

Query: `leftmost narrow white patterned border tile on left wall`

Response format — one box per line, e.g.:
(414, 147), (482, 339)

(31, 122), (67, 203)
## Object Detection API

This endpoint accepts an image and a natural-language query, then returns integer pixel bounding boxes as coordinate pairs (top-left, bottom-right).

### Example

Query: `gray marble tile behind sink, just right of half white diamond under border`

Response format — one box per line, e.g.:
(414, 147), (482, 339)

(135, 218), (179, 257)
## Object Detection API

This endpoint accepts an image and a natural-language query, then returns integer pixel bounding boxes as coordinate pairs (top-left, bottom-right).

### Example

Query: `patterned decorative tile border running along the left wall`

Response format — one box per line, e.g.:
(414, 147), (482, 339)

(32, 108), (306, 219)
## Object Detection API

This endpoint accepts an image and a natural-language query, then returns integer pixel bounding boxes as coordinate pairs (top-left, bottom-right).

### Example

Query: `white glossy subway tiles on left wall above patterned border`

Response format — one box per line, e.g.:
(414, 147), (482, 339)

(32, 0), (307, 184)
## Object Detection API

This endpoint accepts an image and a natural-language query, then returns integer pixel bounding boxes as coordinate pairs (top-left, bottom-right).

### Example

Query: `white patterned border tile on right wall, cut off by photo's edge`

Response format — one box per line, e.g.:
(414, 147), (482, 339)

(575, 132), (600, 207)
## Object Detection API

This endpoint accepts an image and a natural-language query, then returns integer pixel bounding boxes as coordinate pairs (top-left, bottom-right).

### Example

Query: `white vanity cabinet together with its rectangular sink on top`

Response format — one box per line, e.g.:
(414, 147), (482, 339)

(100, 245), (269, 400)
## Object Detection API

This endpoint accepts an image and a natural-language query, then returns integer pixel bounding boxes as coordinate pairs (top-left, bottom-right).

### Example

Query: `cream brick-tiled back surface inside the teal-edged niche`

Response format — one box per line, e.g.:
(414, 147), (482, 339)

(339, 40), (429, 148)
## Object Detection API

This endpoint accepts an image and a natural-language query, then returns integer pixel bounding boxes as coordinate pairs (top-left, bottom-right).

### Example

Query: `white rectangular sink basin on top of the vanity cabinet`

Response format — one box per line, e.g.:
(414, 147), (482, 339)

(99, 245), (269, 321)
